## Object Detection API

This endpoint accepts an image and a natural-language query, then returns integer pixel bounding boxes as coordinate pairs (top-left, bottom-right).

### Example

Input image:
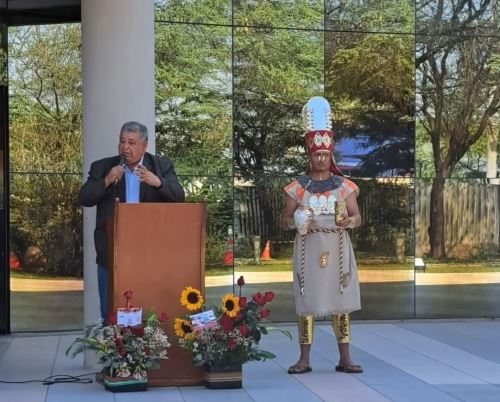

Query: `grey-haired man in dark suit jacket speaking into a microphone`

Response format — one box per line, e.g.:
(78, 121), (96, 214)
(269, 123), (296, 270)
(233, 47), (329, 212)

(79, 121), (184, 321)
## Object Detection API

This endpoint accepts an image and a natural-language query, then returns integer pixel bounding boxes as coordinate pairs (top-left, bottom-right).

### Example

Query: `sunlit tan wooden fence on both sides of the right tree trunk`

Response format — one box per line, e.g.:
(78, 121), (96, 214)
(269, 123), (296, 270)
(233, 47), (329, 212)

(415, 180), (500, 258)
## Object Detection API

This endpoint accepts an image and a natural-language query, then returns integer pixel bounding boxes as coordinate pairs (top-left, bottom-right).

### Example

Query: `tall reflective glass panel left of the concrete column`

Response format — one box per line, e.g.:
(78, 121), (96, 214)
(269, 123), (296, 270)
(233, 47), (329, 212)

(9, 25), (83, 331)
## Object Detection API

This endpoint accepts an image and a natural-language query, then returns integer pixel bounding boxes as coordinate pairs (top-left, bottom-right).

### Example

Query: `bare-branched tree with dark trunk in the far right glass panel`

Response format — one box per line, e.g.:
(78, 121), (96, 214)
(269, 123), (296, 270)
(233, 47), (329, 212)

(416, 0), (500, 258)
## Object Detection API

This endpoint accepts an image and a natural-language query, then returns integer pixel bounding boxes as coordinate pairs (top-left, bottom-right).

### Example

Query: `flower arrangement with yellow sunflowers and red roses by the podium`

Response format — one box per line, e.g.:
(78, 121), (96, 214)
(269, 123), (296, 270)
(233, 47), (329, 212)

(174, 276), (291, 366)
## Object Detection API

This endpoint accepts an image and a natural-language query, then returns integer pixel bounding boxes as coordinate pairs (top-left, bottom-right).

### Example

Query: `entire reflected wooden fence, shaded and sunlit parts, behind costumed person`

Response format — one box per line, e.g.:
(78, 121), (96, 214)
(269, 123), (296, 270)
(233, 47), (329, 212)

(234, 179), (500, 258)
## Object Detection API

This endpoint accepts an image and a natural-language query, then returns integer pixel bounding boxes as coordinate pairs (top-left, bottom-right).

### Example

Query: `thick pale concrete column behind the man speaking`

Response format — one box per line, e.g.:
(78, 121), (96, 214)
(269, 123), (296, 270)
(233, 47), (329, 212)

(82, 0), (155, 340)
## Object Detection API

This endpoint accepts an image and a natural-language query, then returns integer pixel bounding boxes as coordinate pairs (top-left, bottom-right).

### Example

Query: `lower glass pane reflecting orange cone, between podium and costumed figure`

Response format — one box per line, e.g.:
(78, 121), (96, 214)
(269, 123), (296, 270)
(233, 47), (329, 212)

(234, 176), (296, 322)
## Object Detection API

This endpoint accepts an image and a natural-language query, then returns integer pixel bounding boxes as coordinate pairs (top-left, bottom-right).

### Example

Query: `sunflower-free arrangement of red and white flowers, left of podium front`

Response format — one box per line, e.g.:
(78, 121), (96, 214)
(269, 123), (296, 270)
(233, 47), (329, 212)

(66, 290), (170, 379)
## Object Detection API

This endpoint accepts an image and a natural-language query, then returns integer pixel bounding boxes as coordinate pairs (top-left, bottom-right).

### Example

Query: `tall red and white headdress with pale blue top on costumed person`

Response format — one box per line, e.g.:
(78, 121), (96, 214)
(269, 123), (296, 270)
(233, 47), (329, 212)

(302, 96), (343, 176)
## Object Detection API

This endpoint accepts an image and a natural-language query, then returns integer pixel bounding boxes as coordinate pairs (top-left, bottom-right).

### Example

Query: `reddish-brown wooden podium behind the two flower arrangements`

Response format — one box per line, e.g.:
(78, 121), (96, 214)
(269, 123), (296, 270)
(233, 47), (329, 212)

(106, 203), (206, 386)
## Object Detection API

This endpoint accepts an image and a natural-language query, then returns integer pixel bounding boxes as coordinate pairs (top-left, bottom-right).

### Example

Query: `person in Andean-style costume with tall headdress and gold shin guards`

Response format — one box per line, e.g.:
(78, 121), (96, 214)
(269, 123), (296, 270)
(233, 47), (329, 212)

(282, 96), (363, 374)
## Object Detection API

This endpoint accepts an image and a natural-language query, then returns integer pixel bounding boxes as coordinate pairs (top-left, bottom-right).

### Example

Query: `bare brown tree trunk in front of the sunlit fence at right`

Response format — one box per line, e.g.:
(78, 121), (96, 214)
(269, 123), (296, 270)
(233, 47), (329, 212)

(428, 177), (446, 260)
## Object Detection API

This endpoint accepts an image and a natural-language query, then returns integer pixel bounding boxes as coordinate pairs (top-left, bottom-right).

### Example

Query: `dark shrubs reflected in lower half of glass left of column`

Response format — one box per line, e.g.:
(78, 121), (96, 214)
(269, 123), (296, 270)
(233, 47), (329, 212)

(10, 174), (83, 277)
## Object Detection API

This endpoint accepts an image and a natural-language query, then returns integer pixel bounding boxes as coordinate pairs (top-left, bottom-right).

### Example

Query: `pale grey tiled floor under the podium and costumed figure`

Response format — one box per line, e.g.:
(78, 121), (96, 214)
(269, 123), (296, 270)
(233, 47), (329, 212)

(0, 320), (500, 402)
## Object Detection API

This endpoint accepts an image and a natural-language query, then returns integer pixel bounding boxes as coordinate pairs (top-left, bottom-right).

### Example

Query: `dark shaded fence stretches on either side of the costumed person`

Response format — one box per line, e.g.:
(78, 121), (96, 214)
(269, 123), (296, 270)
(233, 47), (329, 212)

(234, 178), (414, 255)
